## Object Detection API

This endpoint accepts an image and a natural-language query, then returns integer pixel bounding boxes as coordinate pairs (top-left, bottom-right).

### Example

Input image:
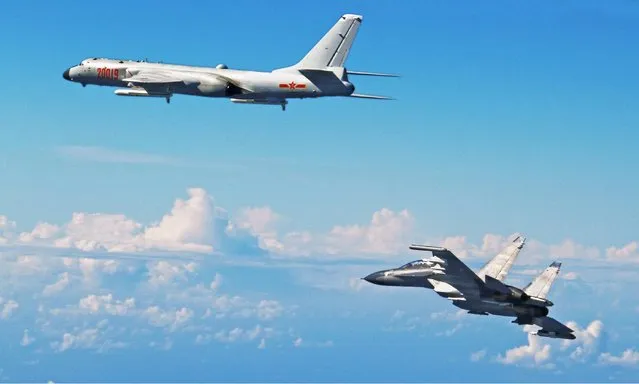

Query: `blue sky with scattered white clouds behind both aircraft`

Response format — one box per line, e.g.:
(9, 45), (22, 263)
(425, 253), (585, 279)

(0, 0), (639, 382)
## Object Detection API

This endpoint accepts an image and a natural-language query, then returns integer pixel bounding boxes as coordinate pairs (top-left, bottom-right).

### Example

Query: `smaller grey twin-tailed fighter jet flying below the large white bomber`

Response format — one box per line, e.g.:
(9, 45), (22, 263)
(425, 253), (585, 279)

(364, 235), (575, 340)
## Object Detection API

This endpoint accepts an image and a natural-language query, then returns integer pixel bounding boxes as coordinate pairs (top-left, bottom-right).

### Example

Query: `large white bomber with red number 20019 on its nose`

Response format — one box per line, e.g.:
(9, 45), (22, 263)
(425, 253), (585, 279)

(62, 14), (398, 110)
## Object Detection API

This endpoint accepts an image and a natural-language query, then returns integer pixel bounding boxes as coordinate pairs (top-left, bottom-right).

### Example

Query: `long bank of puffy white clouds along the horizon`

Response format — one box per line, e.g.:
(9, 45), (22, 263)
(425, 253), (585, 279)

(0, 188), (639, 268)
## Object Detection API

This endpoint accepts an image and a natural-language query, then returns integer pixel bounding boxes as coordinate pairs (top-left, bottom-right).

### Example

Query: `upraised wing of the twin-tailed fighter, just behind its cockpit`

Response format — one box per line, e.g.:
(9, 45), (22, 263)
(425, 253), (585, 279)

(409, 244), (485, 298)
